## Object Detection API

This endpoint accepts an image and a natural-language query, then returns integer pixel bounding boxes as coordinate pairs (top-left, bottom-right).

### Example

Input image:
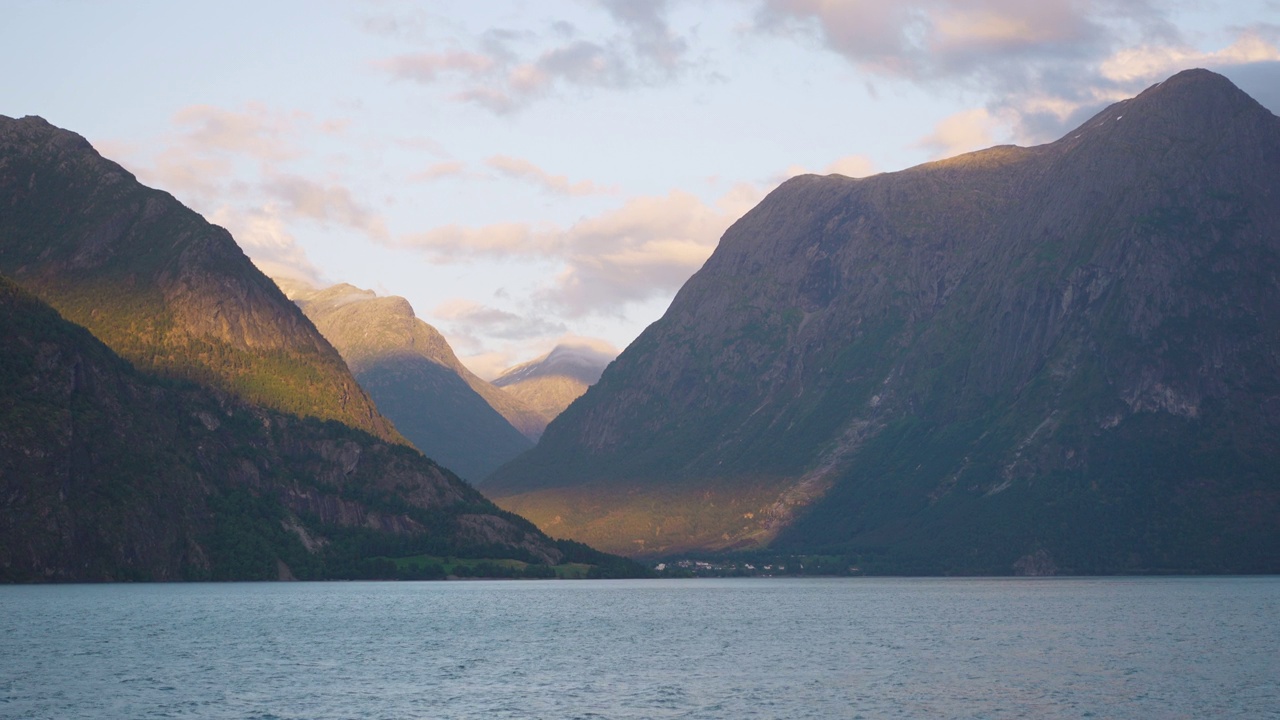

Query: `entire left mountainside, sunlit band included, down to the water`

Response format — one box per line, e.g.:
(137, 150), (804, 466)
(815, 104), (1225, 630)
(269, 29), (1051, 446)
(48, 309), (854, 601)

(0, 117), (639, 582)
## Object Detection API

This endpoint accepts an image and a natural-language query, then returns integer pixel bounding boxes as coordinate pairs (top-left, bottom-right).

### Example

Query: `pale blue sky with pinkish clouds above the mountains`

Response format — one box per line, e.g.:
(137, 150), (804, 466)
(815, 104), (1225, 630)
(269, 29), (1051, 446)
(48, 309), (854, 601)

(0, 0), (1280, 378)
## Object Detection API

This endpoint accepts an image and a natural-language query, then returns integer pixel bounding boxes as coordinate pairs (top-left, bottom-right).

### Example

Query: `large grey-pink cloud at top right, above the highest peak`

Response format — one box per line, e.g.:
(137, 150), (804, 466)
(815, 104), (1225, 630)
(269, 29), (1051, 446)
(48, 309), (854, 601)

(753, 0), (1280, 144)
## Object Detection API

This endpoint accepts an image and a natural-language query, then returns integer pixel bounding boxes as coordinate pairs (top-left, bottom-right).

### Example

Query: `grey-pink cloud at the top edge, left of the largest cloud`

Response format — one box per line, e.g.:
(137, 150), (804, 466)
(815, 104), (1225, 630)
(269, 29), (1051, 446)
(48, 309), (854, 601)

(366, 0), (689, 114)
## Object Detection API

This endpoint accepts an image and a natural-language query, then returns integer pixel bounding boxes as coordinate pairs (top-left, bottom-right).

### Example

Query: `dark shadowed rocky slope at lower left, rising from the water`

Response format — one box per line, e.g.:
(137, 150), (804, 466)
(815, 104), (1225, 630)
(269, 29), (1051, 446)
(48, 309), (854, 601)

(0, 278), (566, 582)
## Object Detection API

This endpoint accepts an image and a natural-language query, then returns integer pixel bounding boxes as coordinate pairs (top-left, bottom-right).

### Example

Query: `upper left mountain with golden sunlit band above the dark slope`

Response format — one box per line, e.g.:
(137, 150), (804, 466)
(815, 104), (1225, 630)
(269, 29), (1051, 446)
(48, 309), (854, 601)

(0, 115), (403, 442)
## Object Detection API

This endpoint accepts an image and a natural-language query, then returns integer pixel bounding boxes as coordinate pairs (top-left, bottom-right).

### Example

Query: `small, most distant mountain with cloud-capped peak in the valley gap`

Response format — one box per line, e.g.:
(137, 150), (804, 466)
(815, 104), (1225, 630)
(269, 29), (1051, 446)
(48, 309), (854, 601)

(493, 343), (614, 424)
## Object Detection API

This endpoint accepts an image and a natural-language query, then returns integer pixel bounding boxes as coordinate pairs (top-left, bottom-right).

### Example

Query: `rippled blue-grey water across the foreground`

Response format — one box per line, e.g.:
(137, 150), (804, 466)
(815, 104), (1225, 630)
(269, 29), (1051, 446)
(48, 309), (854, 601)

(0, 578), (1280, 719)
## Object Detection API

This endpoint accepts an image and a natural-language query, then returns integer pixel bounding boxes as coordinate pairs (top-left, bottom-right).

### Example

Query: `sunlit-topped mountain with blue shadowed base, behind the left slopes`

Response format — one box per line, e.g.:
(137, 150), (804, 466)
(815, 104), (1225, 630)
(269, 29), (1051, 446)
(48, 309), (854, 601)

(276, 279), (545, 480)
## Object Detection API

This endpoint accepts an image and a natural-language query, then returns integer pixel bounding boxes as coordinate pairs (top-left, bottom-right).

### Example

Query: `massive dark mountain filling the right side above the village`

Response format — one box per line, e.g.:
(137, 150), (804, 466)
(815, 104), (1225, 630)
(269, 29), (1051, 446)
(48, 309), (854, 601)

(485, 70), (1280, 574)
